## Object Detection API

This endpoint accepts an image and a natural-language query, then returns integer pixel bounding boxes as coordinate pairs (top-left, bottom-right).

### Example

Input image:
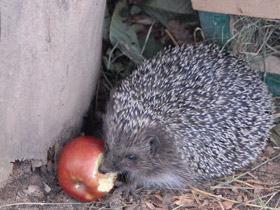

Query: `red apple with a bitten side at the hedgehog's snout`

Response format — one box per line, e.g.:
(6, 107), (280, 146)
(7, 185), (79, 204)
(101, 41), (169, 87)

(57, 136), (116, 201)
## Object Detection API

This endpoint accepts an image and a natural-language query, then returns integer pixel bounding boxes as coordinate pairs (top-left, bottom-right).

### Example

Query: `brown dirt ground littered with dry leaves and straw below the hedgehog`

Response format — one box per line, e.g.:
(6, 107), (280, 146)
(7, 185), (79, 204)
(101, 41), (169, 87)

(0, 139), (280, 210)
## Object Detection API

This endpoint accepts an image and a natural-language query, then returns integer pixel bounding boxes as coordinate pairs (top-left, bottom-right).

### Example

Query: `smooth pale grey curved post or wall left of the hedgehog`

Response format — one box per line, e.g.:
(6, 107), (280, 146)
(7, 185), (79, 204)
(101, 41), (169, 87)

(0, 0), (105, 182)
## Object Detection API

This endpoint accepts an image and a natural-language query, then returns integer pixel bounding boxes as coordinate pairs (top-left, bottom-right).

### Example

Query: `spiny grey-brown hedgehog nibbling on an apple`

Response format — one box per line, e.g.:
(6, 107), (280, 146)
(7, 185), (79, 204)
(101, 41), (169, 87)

(99, 44), (273, 192)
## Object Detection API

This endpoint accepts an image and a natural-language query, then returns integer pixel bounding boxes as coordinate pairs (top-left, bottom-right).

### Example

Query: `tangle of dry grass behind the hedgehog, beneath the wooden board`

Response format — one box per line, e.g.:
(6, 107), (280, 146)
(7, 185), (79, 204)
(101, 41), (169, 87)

(225, 15), (280, 60)
